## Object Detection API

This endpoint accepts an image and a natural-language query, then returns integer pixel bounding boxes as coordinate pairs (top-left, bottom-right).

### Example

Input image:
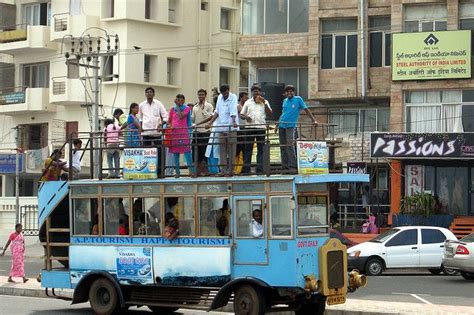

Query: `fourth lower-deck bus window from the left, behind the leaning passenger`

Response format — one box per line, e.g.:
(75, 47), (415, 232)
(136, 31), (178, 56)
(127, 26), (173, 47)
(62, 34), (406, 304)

(165, 197), (195, 236)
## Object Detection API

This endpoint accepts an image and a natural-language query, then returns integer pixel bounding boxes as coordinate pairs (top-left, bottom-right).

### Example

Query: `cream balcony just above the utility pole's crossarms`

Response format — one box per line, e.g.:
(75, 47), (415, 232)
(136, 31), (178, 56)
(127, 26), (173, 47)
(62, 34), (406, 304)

(51, 12), (100, 41)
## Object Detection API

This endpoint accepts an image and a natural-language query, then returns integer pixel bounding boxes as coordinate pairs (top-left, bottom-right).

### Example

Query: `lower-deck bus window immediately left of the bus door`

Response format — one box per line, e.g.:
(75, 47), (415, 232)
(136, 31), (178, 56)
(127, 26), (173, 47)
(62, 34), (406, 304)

(198, 197), (230, 236)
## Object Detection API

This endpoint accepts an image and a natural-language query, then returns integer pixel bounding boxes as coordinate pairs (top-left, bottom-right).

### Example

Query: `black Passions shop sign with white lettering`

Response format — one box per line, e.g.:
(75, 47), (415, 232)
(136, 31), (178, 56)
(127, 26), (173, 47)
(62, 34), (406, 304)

(370, 132), (474, 159)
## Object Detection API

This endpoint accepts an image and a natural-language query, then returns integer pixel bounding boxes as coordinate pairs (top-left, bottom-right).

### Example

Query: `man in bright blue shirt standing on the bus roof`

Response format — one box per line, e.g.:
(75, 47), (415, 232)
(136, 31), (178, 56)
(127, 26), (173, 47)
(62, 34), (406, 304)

(277, 85), (318, 172)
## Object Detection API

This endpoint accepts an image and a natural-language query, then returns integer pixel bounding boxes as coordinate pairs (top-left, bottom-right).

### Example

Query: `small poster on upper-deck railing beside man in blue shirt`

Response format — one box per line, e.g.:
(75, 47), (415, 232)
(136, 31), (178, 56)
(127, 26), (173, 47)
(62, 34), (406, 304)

(296, 141), (329, 174)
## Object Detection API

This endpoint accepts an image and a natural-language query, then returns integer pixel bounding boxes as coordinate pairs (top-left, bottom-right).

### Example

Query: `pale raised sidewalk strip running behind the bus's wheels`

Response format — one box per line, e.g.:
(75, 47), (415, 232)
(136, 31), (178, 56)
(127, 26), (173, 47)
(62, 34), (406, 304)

(0, 276), (474, 315)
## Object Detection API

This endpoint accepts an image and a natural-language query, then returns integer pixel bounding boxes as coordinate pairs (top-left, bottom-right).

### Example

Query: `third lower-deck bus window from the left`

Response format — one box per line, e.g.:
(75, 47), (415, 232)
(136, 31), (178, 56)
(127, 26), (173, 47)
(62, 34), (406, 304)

(133, 198), (161, 235)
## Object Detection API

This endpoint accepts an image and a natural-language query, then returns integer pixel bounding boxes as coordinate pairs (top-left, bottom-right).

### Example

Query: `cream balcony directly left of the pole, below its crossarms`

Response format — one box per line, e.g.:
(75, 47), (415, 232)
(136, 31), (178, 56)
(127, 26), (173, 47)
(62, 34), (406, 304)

(49, 76), (86, 105)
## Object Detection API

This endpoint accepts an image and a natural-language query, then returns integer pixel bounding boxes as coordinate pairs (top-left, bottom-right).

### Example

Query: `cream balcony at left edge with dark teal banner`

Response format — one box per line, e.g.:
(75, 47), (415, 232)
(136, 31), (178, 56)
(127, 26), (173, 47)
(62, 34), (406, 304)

(0, 86), (56, 116)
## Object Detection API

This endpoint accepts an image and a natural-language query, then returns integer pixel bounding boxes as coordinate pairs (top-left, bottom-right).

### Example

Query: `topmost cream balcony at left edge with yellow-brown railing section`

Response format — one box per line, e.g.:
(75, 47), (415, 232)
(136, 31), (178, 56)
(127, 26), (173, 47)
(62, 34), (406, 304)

(0, 24), (57, 54)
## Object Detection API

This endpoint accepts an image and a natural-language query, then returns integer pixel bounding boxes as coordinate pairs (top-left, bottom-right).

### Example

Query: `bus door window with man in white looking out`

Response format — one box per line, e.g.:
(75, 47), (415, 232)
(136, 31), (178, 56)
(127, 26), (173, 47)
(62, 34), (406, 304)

(236, 199), (265, 238)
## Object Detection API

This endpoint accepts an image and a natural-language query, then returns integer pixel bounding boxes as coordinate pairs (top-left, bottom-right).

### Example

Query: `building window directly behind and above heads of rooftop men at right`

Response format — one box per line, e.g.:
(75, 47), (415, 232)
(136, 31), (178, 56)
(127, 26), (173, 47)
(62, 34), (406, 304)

(257, 68), (308, 99)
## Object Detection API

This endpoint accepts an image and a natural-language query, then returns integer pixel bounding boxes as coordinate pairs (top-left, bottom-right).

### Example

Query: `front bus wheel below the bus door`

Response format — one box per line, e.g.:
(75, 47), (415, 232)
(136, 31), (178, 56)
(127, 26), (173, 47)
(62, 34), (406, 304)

(234, 285), (265, 315)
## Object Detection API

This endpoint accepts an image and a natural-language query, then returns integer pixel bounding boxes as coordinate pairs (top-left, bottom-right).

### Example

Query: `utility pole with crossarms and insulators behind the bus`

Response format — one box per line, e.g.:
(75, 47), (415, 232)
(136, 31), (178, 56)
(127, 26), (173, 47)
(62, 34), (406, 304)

(63, 33), (119, 178)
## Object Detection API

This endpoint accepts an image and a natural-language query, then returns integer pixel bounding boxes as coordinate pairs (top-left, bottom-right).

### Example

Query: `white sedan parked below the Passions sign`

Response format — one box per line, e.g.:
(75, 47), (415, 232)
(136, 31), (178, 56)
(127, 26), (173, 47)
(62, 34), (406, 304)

(347, 226), (457, 276)
